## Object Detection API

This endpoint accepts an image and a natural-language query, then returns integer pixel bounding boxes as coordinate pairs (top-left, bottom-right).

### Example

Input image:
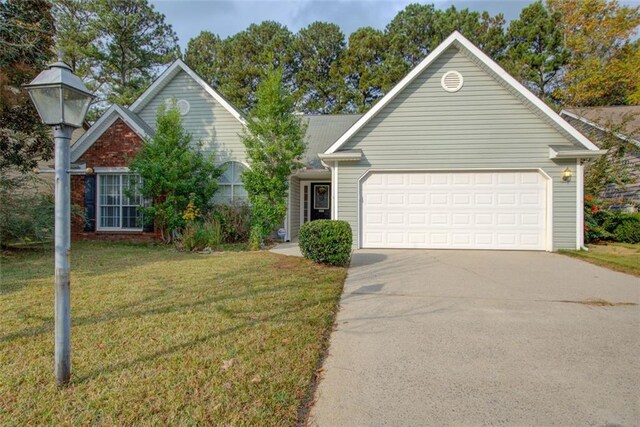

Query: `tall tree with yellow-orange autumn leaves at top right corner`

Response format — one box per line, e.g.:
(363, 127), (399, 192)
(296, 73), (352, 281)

(548, 0), (640, 106)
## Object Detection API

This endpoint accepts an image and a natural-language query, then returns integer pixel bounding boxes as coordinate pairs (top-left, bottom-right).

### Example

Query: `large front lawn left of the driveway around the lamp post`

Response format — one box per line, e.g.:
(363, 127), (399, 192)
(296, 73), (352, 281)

(0, 243), (346, 426)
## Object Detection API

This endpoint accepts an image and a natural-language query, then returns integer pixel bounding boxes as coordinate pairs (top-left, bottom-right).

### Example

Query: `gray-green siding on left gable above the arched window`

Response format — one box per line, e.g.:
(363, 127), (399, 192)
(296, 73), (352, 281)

(138, 70), (246, 163)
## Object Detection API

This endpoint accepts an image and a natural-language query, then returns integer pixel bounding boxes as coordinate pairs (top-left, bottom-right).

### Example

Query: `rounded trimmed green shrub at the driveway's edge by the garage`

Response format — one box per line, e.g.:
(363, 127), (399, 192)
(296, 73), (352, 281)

(298, 219), (353, 265)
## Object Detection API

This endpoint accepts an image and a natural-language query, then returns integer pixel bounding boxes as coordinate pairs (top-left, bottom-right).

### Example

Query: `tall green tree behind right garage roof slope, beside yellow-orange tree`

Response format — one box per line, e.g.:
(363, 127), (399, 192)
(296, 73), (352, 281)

(503, 0), (570, 100)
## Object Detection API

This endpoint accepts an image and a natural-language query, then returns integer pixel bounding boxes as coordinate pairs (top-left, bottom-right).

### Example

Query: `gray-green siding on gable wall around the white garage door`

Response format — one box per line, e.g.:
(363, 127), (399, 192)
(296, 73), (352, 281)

(338, 47), (576, 250)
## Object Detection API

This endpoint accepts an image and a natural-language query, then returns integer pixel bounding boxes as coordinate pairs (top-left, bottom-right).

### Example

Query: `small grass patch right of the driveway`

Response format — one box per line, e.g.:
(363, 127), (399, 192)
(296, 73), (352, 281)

(562, 243), (640, 277)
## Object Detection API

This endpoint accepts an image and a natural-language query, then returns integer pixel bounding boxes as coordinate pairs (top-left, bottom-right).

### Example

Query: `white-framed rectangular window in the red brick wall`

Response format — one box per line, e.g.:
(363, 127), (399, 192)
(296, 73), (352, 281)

(98, 174), (144, 230)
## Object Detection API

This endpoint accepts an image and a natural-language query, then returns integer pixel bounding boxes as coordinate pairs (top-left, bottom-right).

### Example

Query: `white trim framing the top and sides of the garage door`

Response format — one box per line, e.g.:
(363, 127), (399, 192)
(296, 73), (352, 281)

(357, 168), (553, 252)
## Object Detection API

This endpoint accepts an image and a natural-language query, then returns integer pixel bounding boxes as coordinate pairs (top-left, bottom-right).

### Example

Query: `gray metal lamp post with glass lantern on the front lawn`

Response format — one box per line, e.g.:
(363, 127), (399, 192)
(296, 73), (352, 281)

(25, 61), (93, 386)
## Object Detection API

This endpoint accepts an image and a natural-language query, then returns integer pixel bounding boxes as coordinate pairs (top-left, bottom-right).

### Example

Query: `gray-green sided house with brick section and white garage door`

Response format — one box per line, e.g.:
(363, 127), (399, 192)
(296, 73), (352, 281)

(71, 32), (603, 251)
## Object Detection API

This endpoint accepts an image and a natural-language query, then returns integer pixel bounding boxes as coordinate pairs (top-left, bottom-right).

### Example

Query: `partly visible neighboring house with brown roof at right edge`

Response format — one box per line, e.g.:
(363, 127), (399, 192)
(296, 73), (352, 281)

(560, 105), (640, 211)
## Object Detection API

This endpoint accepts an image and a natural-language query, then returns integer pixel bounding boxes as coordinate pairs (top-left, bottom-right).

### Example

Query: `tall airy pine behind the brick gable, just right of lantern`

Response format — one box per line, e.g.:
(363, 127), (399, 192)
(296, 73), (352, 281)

(54, 0), (180, 112)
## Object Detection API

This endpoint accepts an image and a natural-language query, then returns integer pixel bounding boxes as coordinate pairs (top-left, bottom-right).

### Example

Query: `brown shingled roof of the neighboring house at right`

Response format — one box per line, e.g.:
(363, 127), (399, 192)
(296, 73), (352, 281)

(560, 105), (640, 144)
